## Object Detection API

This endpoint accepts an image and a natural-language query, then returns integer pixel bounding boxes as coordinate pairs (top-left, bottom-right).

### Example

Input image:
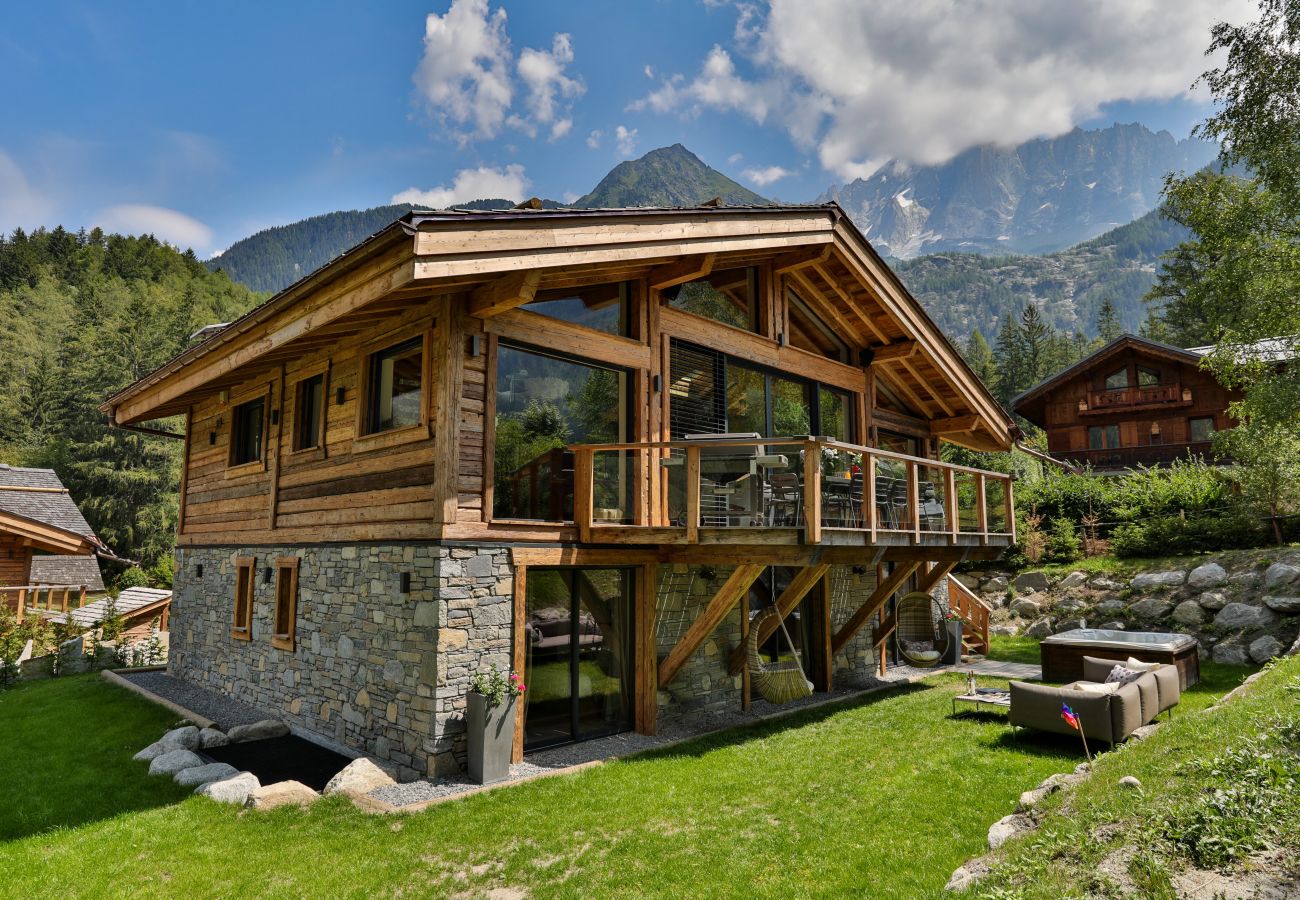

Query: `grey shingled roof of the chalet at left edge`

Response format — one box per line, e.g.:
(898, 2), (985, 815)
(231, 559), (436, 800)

(0, 464), (107, 554)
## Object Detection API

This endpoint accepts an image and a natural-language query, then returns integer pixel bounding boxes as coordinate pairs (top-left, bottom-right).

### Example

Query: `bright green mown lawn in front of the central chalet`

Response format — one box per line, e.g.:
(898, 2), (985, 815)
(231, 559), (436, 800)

(0, 658), (1245, 897)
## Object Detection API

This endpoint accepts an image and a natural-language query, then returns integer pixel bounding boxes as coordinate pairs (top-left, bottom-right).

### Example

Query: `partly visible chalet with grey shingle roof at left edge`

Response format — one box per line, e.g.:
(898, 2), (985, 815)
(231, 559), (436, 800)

(0, 464), (112, 609)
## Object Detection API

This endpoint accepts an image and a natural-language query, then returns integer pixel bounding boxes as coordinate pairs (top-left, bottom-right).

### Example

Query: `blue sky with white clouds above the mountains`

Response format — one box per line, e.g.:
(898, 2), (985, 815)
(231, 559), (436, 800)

(0, 0), (1249, 256)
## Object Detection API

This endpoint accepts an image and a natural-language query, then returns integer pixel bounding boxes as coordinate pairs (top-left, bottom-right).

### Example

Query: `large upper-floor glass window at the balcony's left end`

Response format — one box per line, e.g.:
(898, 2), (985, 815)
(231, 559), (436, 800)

(493, 345), (634, 522)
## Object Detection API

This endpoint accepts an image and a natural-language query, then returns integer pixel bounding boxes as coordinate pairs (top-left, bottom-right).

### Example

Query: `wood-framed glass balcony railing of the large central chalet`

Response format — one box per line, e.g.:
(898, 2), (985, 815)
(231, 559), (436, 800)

(569, 434), (1015, 548)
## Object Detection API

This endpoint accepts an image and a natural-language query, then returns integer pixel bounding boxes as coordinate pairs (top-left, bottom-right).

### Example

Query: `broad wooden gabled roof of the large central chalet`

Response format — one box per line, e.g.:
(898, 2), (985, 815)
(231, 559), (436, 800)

(101, 203), (1017, 450)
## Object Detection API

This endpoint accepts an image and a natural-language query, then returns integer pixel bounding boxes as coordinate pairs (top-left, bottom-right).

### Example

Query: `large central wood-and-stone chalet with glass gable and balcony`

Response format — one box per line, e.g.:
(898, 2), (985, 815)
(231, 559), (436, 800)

(104, 204), (1014, 774)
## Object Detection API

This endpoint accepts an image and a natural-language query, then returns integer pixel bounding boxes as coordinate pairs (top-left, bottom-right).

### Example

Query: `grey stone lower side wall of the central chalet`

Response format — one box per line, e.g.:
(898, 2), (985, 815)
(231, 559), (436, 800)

(170, 544), (514, 779)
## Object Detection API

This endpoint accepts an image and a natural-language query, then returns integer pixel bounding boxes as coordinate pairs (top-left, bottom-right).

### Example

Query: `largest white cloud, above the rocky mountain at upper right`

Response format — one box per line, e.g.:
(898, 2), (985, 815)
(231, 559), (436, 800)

(631, 0), (1253, 177)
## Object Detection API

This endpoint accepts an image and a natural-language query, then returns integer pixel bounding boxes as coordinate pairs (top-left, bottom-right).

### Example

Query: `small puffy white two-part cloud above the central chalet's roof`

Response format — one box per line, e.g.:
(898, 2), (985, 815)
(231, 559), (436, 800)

(412, 0), (586, 144)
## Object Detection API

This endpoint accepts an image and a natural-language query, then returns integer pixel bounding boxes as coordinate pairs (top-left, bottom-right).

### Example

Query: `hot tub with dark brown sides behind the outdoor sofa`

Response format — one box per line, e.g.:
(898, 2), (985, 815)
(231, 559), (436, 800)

(1040, 628), (1201, 691)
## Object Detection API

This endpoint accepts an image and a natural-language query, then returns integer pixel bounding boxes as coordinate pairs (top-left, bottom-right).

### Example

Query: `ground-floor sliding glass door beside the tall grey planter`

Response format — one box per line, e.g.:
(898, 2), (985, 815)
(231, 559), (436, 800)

(524, 568), (634, 750)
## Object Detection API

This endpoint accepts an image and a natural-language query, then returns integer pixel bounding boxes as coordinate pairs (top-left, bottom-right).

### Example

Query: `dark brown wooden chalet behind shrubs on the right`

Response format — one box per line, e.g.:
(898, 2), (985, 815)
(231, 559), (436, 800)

(1013, 334), (1240, 472)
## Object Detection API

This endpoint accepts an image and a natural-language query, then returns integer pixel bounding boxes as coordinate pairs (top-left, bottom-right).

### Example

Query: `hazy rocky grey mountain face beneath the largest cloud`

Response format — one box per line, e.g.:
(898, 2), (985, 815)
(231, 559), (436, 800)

(820, 124), (1218, 259)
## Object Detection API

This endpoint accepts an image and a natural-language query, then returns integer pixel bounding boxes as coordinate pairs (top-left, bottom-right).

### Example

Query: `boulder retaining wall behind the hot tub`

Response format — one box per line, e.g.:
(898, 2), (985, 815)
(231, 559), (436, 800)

(958, 550), (1300, 666)
